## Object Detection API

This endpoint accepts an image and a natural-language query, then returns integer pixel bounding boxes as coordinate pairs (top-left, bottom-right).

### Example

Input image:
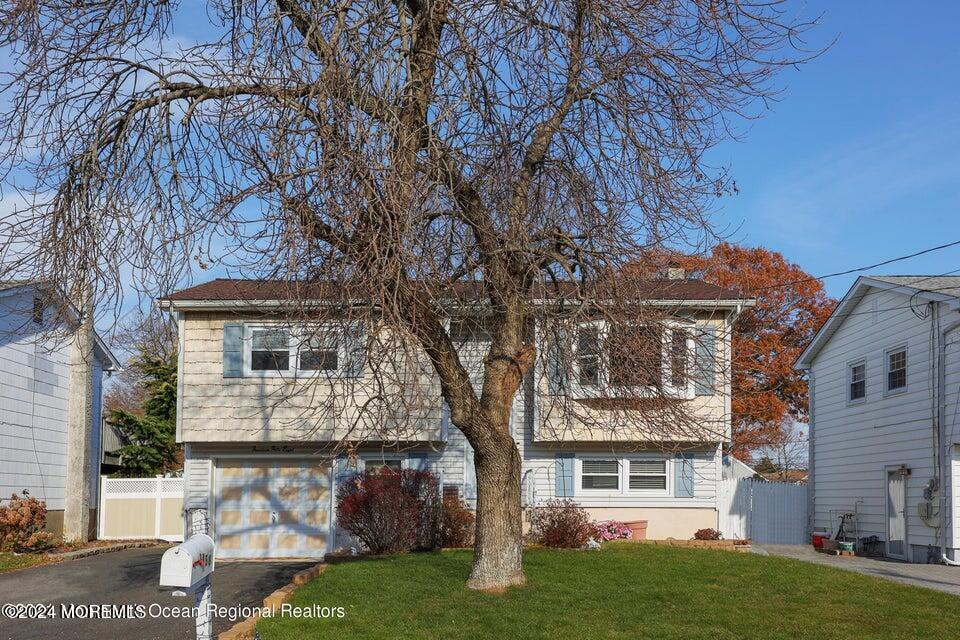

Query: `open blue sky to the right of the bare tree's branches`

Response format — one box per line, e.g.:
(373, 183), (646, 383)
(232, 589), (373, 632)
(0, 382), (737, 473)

(713, 0), (960, 296)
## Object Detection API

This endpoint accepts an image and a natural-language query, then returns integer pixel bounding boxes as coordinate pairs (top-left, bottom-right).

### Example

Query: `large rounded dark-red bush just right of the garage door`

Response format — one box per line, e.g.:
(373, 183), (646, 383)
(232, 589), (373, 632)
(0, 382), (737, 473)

(337, 469), (441, 554)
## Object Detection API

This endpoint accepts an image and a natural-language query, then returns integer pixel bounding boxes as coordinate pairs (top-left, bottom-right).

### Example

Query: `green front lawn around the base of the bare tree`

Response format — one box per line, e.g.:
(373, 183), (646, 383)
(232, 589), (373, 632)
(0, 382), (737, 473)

(259, 544), (960, 640)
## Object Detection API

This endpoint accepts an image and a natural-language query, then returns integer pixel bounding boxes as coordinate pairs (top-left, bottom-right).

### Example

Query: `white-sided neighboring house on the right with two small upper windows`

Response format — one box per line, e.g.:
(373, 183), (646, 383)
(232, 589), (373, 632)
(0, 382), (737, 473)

(797, 276), (960, 562)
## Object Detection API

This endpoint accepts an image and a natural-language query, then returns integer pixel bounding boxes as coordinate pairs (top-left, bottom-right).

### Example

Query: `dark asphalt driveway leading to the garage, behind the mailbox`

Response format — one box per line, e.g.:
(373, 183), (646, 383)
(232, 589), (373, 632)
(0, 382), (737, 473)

(0, 547), (314, 640)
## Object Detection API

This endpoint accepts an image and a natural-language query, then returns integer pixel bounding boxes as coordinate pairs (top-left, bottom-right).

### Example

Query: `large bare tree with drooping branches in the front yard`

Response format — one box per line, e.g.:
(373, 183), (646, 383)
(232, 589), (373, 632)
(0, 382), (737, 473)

(0, 0), (808, 588)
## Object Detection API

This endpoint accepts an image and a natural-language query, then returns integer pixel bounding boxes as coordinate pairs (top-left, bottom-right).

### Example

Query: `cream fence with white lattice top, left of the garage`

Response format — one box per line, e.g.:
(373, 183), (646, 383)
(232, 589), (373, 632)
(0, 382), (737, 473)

(98, 476), (183, 542)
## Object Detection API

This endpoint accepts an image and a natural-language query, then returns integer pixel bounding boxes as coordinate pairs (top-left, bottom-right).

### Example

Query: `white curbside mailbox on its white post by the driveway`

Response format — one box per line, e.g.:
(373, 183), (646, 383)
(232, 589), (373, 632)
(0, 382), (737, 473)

(160, 533), (215, 640)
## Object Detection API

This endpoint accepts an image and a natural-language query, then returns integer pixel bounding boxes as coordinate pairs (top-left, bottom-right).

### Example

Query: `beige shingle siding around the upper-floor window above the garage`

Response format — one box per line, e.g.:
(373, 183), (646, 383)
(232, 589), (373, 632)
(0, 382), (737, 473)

(181, 313), (441, 442)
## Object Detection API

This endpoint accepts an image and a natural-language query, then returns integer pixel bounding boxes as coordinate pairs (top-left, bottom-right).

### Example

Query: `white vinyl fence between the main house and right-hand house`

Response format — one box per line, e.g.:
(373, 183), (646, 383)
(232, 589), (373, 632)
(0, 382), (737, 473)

(718, 478), (809, 544)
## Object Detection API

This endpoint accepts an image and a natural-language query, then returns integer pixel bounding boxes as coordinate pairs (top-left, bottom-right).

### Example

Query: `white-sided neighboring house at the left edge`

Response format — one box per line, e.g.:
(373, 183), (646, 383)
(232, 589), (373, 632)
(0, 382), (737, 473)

(0, 282), (120, 533)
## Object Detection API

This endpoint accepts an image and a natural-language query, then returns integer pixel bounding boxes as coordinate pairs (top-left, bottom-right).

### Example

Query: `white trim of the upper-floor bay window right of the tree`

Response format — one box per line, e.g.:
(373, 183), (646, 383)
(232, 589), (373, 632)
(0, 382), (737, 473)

(570, 320), (697, 400)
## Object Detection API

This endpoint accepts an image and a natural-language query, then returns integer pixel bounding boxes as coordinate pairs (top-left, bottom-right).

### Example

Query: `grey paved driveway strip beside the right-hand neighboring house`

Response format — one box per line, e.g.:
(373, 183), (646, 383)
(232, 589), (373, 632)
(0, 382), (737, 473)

(755, 544), (960, 596)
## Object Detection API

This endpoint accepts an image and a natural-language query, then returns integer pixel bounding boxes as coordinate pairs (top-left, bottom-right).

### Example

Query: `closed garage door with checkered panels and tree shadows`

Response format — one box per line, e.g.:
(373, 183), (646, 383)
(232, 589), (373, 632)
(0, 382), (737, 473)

(215, 460), (331, 558)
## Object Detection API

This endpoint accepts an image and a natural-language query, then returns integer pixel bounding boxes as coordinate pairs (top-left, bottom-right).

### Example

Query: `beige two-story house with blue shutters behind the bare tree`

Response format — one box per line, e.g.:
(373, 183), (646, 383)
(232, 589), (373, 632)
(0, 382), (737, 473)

(161, 279), (751, 557)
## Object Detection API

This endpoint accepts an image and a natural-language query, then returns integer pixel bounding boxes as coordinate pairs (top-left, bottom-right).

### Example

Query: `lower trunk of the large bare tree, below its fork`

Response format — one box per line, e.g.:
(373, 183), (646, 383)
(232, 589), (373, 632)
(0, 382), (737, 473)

(467, 432), (526, 591)
